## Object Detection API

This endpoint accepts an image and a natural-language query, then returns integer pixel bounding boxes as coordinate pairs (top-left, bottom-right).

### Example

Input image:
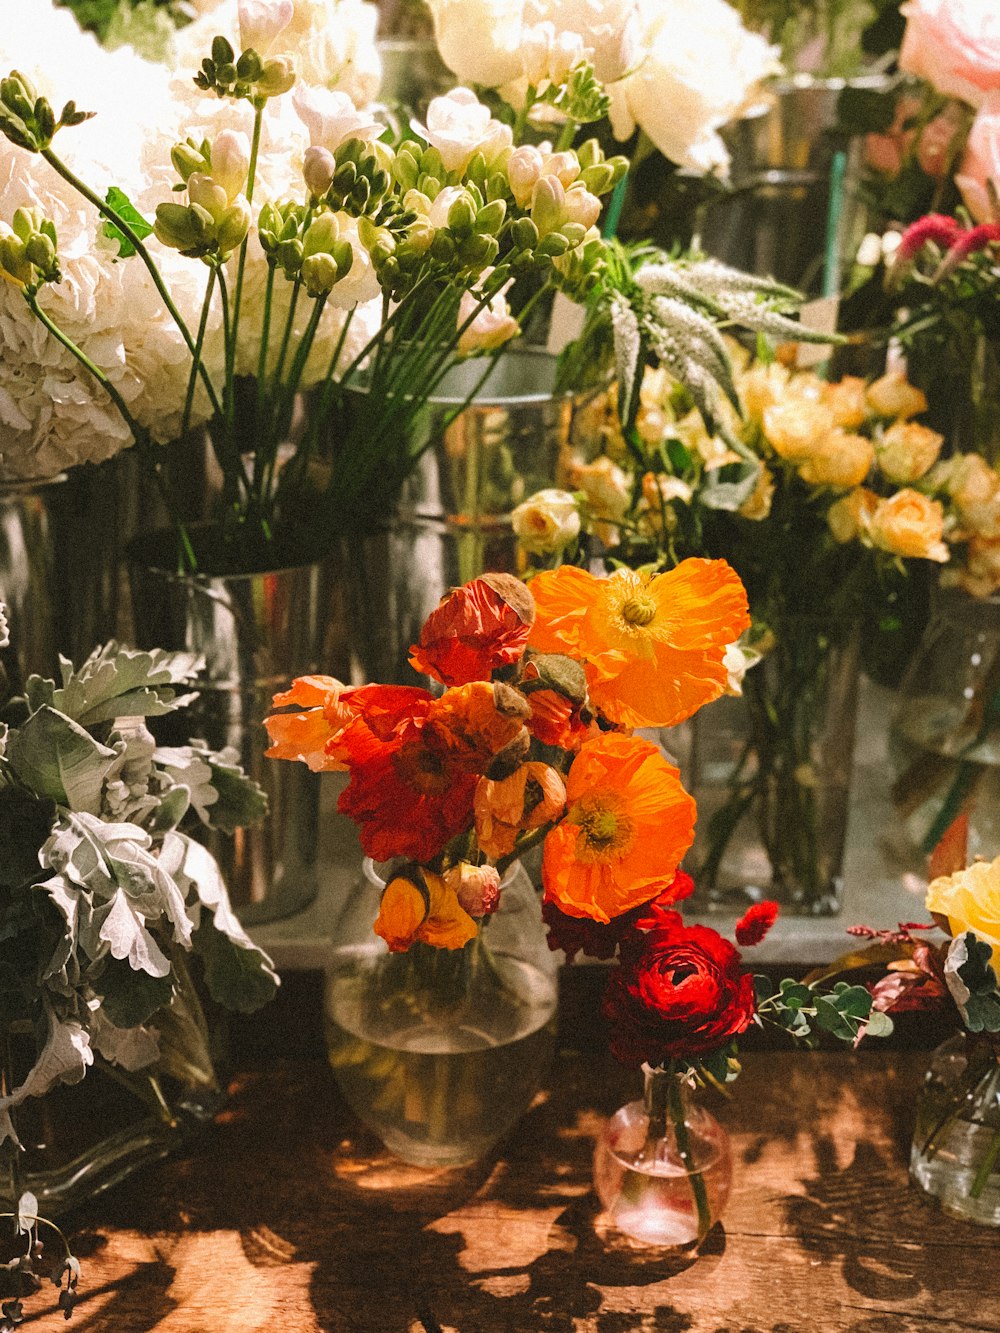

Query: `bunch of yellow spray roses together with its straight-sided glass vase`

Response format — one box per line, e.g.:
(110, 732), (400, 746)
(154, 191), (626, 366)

(515, 343), (976, 913)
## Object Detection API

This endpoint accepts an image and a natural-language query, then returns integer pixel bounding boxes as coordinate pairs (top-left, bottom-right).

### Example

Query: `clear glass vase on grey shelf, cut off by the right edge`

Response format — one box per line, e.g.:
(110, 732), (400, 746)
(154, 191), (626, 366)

(889, 588), (1000, 872)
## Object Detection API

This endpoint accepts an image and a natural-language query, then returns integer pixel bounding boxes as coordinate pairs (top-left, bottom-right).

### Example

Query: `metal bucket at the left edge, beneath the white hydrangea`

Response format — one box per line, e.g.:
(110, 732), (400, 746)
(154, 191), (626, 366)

(0, 455), (136, 690)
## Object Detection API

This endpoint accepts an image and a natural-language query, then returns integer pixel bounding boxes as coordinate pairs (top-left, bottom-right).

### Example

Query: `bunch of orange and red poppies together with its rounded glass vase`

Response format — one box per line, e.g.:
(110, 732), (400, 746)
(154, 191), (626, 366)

(267, 560), (747, 1164)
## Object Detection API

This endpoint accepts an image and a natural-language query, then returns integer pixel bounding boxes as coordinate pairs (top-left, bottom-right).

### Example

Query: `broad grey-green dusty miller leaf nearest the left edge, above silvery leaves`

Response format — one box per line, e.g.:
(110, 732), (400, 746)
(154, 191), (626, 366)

(7, 706), (117, 814)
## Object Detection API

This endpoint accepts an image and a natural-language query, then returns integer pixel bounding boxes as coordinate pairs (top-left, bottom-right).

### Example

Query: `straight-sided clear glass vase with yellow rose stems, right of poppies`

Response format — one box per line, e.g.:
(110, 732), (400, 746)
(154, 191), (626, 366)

(677, 617), (860, 916)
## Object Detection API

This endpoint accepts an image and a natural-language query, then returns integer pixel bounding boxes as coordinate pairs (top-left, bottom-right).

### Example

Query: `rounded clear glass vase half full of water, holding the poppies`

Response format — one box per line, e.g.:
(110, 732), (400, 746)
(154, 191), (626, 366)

(325, 861), (557, 1166)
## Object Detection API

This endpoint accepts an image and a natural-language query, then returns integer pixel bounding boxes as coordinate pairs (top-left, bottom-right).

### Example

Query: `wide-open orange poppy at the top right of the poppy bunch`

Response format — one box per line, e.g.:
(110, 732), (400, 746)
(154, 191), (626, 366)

(529, 560), (749, 726)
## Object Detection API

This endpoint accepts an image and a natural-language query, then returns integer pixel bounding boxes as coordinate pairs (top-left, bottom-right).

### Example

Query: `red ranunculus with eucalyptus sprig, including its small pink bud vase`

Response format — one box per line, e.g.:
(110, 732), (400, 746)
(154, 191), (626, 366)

(584, 890), (892, 1245)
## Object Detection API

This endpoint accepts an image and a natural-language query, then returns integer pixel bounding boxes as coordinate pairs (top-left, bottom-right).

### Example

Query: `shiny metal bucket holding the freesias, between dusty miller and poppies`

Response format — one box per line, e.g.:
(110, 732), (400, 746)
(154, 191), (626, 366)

(129, 555), (349, 925)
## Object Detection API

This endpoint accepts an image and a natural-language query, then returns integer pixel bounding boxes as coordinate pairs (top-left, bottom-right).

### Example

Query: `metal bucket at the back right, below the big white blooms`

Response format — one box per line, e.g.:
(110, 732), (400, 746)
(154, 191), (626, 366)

(699, 75), (887, 296)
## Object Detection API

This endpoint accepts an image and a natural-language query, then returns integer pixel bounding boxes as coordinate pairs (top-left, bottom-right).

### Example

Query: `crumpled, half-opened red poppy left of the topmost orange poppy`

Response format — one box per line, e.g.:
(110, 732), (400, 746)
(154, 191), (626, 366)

(409, 575), (535, 685)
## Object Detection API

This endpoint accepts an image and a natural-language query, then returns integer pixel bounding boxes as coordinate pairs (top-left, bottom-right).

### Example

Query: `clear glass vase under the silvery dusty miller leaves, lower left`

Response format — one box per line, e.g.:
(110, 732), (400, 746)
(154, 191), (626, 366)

(0, 953), (225, 1218)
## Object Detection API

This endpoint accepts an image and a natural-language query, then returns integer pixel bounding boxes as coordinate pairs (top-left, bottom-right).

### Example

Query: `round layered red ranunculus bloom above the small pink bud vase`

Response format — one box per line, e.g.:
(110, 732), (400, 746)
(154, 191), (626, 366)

(603, 909), (755, 1065)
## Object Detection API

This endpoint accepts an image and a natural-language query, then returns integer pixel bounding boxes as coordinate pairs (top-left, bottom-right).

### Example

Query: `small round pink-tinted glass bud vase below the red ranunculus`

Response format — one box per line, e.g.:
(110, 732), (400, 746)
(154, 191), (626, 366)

(593, 1065), (732, 1246)
